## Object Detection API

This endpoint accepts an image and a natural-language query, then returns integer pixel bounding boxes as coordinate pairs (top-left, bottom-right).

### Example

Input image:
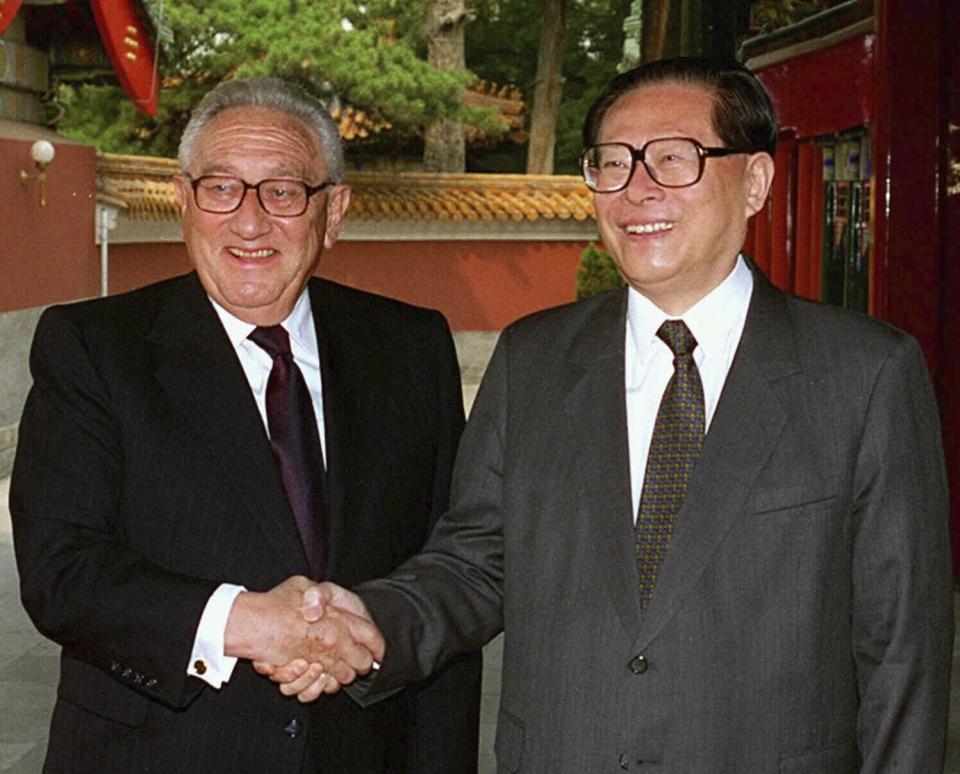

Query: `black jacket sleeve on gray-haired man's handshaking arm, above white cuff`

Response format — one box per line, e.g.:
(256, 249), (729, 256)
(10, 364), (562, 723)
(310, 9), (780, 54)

(10, 307), (217, 706)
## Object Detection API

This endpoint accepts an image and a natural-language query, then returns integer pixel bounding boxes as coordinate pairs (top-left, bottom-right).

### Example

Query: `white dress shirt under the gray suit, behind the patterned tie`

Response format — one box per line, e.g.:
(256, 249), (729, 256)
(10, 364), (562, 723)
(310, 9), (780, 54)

(624, 256), (753, 521)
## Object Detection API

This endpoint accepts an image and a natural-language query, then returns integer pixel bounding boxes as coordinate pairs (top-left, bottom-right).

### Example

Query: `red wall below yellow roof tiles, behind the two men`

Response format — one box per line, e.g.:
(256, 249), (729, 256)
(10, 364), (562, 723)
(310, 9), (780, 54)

(110, 240), (584, 331)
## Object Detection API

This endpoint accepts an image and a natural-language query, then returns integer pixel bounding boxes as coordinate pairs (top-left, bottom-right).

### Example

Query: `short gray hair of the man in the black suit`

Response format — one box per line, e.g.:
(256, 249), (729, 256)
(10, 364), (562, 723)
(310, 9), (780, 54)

(177, 78), (344, 183)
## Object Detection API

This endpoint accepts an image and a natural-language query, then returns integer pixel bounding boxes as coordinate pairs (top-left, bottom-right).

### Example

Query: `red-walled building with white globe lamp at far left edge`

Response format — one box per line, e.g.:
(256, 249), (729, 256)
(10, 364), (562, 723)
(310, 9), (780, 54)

(0, 0), (157, 475)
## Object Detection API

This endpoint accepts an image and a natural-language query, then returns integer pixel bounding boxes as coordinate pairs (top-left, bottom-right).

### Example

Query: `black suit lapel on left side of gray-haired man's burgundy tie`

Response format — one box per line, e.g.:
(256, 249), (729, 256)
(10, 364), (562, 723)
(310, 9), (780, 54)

(148, 275), (307, 572)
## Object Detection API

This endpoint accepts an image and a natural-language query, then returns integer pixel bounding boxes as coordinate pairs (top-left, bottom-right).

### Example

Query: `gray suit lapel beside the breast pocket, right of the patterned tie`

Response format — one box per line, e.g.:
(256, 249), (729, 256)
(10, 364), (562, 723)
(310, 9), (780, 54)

(637, 270), (800, 650)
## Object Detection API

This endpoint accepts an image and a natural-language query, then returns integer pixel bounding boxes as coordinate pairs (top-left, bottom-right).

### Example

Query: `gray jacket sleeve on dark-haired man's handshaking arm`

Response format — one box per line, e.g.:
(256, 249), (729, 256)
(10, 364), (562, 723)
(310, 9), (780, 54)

(357, 334), (507, 699)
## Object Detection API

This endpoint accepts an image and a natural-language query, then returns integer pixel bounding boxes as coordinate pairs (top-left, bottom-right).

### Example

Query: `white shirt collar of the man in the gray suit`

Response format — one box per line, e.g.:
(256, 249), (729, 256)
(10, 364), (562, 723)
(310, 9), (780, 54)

(627, 255), (753, 362)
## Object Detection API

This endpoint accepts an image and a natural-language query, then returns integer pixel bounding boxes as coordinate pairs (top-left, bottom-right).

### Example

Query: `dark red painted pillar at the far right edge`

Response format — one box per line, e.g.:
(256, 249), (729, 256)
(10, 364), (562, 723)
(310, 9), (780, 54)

(873, 0), (960, 571)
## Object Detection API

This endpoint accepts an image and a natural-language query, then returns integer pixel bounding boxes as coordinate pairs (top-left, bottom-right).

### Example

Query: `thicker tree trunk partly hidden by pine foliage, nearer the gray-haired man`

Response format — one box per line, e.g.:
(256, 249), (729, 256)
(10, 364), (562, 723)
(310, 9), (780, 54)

(423, 0), (469, 172)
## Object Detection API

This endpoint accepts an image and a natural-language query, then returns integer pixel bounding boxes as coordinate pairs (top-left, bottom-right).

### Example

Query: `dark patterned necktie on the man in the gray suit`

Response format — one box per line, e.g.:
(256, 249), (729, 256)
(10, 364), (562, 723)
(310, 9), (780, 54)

(636, 320), (704, 611)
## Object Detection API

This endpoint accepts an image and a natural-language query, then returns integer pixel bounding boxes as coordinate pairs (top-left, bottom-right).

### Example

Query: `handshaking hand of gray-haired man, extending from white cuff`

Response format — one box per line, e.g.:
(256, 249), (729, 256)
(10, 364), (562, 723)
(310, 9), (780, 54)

(224, 576), (384, 698)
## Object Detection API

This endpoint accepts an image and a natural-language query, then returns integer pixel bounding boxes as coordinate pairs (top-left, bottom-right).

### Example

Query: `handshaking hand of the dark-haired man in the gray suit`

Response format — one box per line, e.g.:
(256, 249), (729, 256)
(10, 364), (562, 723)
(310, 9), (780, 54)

(254, 583), (386, 702)
